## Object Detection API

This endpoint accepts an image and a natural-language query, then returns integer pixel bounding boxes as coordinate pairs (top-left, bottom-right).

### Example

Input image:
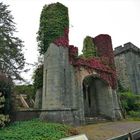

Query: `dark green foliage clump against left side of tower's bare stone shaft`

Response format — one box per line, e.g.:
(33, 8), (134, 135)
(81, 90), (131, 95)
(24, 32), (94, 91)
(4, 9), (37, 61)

(33, 65), (43, 92)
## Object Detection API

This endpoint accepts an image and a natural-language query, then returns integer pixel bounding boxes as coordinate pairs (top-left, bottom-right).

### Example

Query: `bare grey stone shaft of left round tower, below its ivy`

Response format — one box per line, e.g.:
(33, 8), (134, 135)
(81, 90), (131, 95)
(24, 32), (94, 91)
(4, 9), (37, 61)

(40, 43), (74, 124)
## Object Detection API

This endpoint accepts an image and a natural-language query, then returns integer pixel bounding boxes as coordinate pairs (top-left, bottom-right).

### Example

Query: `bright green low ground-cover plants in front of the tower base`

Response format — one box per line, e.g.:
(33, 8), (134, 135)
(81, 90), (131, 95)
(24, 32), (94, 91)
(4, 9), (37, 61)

(0, 120), (76, 140)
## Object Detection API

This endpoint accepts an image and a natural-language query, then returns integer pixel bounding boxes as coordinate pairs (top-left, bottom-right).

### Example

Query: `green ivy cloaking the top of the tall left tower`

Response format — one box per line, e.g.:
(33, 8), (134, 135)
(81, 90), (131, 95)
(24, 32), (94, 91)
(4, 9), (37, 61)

(37, 2), (69, 54)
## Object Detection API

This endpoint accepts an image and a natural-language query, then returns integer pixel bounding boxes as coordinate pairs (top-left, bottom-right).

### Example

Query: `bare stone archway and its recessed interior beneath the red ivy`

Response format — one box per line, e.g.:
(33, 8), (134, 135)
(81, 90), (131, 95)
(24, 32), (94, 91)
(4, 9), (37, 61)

(77, 68), (122, 120)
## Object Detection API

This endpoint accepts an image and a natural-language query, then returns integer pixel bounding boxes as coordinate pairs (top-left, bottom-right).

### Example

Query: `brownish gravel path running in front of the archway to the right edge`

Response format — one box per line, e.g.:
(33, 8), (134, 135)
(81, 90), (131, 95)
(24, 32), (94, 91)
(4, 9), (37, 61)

(76, 121), (140, 140)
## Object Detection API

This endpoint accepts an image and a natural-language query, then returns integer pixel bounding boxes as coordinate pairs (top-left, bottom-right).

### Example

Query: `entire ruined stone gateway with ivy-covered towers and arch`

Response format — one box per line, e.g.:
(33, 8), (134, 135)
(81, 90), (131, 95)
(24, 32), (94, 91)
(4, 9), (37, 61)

(39, 3), (122, 124)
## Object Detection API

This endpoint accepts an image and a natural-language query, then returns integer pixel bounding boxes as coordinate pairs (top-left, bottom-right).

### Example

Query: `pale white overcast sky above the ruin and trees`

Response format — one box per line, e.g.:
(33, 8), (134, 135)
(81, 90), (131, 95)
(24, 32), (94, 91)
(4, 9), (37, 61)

(0, 0), (140, 83)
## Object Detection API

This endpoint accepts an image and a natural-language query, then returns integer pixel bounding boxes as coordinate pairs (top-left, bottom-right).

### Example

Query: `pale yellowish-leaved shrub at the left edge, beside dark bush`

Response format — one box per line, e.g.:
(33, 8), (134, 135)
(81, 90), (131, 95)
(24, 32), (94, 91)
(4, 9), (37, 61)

(0, 92), (10, 127)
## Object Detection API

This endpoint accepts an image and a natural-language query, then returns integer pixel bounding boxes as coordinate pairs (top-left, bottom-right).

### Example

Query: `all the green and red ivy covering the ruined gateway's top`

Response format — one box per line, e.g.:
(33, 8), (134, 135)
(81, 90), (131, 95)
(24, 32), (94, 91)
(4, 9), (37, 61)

(37, 2), (116, 89)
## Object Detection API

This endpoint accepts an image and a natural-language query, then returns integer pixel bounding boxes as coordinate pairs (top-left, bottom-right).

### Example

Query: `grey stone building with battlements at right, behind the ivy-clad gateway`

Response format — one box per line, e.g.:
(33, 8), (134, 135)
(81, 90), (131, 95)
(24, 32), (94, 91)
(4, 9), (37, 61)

(114, 42), (140, 94)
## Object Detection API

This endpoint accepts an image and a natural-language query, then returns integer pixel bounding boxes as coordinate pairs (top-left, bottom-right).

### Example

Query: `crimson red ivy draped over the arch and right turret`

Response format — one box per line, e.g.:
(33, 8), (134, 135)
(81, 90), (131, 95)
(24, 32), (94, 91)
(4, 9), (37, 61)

(54, 29), (117, 89)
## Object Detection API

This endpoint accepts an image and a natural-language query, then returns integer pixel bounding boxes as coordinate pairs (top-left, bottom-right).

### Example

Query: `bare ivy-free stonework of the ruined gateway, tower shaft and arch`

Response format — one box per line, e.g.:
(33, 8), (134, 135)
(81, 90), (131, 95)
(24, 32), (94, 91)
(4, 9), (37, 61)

(40, 44), (121, 125)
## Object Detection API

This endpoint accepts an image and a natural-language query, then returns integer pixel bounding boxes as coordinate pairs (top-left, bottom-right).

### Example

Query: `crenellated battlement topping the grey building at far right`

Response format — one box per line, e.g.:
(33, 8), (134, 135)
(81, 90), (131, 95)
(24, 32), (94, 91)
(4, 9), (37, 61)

(114, 42), (140, 56)
